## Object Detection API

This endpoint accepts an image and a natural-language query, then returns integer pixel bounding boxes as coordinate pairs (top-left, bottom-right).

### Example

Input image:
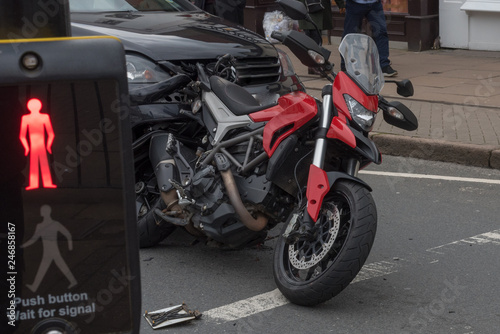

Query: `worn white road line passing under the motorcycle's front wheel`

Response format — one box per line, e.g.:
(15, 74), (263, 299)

(203, 261), (398, 323)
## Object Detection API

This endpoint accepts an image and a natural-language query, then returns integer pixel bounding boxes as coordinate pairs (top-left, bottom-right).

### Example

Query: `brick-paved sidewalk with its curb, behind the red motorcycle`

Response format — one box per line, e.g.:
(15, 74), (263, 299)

(278, 39), (500, 169)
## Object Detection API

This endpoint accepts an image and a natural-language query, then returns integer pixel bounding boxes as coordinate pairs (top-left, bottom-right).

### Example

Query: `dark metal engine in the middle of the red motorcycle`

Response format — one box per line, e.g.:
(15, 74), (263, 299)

(165, 133), (291, 248)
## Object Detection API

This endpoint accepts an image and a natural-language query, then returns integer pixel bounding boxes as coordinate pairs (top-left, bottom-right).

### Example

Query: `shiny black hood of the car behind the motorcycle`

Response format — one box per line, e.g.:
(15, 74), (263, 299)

(71, 12), (277, 61)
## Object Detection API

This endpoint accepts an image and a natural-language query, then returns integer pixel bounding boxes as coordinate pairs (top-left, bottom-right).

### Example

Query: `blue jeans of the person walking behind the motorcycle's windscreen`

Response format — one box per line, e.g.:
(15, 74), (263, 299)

(342, 0), (391, 68)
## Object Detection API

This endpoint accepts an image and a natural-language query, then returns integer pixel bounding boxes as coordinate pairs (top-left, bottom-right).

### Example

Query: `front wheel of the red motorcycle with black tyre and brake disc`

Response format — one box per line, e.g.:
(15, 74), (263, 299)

(273, 180), (377, 306)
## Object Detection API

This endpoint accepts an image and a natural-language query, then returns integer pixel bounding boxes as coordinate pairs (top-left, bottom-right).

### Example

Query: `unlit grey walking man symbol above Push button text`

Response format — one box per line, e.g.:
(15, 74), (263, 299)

(21, 205), (77, 292)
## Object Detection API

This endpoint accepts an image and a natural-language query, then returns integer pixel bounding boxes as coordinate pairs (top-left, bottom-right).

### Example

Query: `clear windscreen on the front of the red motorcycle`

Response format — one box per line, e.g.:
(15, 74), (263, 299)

(339, 34), (385, 95)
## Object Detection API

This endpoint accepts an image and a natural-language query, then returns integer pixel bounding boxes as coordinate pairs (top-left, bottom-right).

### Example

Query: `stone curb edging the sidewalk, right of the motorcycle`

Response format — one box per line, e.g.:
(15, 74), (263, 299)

(370, 133), (500, 169)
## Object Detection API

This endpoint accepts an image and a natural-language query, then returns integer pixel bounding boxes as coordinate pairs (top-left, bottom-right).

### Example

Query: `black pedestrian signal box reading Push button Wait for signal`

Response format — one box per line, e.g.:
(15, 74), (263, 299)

(0, 37), (141, 334)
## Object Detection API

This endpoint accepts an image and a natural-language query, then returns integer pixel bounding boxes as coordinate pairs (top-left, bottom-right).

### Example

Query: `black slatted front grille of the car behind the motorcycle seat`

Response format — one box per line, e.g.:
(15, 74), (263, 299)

(233, 57), (280, 86)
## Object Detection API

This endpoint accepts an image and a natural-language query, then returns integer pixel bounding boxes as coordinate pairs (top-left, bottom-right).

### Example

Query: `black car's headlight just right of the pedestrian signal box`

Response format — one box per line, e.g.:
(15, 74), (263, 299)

(125, 54), (170, 84)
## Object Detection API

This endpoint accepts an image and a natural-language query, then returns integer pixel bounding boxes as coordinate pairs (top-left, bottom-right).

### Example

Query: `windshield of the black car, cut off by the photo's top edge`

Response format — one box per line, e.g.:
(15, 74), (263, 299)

(69, 0), (197, 12)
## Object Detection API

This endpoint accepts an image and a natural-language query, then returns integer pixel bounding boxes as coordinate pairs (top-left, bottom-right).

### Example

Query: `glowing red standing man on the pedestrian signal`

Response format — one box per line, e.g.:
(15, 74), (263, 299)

(19, 99), (57, 190)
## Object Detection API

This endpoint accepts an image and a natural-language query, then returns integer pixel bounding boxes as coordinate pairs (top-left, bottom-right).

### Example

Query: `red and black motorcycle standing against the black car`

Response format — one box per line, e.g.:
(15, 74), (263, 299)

(134, 0), (417, 305)
